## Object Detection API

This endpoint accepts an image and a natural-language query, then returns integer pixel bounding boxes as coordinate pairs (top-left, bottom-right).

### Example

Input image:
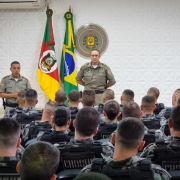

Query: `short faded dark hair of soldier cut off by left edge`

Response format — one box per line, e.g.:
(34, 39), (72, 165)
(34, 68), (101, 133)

(0, 117), (21, 149)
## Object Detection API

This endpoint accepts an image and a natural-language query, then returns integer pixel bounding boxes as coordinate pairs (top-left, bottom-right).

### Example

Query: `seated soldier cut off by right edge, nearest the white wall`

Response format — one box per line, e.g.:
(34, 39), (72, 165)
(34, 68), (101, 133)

(158, 89), (180, 119)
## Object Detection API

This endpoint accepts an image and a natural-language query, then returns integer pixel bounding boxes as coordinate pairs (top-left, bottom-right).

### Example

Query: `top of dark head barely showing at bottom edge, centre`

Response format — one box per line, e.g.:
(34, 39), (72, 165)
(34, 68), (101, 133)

(73, 172), (111, 180)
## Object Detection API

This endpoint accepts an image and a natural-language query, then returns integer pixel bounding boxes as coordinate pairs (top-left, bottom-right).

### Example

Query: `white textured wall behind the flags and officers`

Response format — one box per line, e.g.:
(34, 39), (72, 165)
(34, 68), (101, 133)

(0, 0), (180, 107)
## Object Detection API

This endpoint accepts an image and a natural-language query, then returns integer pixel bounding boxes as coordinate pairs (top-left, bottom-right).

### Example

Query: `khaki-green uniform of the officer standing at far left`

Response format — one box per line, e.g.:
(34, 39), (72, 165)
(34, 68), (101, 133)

(0, 75), (31, 111)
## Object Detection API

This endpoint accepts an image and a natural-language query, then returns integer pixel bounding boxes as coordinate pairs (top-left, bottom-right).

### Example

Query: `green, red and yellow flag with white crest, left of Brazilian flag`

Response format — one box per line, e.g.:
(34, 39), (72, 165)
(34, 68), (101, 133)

(37, 9), (60, 101)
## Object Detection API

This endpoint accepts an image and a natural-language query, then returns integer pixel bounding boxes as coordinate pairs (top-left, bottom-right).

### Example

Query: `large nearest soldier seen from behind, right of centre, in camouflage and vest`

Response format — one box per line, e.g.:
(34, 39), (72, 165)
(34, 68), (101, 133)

(81, 117), (170, 180)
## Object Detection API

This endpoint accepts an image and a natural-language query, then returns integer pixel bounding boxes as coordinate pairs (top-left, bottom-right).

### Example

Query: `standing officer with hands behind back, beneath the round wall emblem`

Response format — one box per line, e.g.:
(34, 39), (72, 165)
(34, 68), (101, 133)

(76, 49), (116, 104)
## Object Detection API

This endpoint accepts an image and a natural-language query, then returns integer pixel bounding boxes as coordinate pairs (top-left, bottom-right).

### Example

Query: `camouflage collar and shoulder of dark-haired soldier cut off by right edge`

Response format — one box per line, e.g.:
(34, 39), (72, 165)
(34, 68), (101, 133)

(140, 136), (180, 159)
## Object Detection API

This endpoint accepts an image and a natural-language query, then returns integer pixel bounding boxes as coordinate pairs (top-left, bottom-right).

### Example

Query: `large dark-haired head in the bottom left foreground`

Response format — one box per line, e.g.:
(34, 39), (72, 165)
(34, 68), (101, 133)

(20, 141), (60, 180)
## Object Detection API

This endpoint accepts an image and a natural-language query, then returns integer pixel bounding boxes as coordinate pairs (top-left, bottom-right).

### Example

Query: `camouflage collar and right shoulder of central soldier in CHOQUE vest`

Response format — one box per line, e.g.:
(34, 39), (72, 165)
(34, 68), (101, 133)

(68, 138), (114, 157)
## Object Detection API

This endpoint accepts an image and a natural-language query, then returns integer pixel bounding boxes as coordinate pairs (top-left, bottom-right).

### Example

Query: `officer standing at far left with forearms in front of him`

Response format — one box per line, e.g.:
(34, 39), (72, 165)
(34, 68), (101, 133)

(0, 61), (31, 112)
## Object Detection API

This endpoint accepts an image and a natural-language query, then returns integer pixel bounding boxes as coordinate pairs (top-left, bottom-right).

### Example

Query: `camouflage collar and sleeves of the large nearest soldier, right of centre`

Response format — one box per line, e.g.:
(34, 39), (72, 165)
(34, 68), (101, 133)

(81, 156), (170, 180)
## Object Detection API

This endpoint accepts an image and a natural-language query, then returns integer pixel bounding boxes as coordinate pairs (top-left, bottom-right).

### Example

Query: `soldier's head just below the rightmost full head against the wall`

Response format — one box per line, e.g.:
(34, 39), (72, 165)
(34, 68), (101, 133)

(141, 95), (155, 112)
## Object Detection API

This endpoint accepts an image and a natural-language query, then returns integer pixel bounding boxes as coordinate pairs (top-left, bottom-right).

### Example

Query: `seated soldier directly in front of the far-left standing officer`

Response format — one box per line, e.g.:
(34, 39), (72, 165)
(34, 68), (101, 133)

(4, 90), (26, 117)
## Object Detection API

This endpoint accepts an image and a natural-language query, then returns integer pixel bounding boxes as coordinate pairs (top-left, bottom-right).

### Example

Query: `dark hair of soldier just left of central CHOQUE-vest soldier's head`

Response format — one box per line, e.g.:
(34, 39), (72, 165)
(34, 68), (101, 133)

(54, 106), (71, 126)
